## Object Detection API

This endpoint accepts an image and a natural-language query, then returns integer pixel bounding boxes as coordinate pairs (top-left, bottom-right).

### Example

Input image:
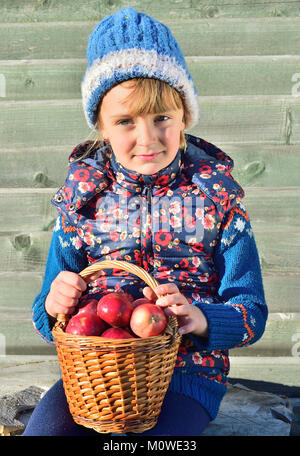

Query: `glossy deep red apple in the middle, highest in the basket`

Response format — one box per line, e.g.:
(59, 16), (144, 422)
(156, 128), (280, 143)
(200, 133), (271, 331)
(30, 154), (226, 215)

(97, 293), (132, 328)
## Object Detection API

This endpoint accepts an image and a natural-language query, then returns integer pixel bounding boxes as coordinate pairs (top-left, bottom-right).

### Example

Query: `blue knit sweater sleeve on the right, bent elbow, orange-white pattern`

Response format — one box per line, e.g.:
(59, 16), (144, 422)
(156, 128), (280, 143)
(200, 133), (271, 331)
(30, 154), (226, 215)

(192, 204), (268, 350)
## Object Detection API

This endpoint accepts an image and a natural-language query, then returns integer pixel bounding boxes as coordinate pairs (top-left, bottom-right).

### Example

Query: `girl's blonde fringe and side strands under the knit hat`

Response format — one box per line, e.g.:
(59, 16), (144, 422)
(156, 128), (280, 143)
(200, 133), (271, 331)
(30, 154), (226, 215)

(84, 78), (190, 161)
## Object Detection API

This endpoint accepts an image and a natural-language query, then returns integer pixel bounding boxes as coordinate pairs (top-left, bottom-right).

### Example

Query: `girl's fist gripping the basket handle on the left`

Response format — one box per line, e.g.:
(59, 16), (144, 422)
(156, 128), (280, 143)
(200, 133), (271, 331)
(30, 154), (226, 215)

(45, 271), (87, 318)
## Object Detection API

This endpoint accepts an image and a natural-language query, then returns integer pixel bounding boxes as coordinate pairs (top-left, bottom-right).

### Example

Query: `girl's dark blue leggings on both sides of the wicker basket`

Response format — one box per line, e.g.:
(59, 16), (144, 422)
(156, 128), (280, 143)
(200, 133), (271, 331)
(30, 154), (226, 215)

(23, 380), (210, 436)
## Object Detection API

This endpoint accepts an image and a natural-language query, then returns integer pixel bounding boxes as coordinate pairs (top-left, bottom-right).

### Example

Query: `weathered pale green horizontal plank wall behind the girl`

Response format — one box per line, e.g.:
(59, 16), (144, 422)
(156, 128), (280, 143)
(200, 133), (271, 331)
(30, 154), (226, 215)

(0, 0), (300, 386)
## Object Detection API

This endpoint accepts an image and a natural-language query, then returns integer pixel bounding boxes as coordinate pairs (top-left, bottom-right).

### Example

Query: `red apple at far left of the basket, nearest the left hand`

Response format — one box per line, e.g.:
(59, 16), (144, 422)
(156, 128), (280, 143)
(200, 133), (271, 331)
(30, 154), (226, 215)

(65, 312), (107, 336)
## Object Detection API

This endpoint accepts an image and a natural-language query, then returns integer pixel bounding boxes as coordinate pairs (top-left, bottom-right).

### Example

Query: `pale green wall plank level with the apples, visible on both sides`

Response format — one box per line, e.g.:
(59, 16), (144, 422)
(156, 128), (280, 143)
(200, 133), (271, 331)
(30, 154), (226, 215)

(0, 271), (300, 314)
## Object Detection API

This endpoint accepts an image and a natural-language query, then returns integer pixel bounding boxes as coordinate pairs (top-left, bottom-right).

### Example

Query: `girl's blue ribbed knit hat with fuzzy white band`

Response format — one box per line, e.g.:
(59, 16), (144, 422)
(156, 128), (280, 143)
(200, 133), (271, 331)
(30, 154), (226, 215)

(81, 7), (198, 129)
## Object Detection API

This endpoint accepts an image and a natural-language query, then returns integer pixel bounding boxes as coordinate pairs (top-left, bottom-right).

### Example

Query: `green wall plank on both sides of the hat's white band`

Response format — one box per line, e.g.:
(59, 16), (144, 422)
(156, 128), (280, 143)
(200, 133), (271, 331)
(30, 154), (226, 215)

(0, 55), (300, 101)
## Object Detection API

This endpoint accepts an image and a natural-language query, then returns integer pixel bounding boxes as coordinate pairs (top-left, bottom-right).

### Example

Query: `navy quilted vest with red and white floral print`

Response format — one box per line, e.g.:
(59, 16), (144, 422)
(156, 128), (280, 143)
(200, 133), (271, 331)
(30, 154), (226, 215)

(52, 135), (244, 375)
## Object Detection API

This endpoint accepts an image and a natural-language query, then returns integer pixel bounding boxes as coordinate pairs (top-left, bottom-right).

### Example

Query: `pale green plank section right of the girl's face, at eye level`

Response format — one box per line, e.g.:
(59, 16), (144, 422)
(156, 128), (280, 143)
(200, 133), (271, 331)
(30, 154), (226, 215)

(191, 96), (300, 144)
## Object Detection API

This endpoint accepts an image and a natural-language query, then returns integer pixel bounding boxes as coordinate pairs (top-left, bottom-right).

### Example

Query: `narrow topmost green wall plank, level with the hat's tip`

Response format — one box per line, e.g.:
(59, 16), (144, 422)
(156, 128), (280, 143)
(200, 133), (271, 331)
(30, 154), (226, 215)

(0, 0), (299, 22)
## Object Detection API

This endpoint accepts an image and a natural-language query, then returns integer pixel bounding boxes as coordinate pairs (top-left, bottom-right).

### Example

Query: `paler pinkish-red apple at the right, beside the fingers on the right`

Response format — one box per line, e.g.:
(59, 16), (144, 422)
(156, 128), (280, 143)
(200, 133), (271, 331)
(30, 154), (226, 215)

(130, 303), (167, 337)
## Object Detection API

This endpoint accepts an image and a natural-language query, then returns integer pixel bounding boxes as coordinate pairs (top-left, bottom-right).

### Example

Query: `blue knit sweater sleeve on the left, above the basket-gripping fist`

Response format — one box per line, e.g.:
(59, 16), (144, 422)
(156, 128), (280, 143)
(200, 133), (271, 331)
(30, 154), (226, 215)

(32, 214), (87, 343)
